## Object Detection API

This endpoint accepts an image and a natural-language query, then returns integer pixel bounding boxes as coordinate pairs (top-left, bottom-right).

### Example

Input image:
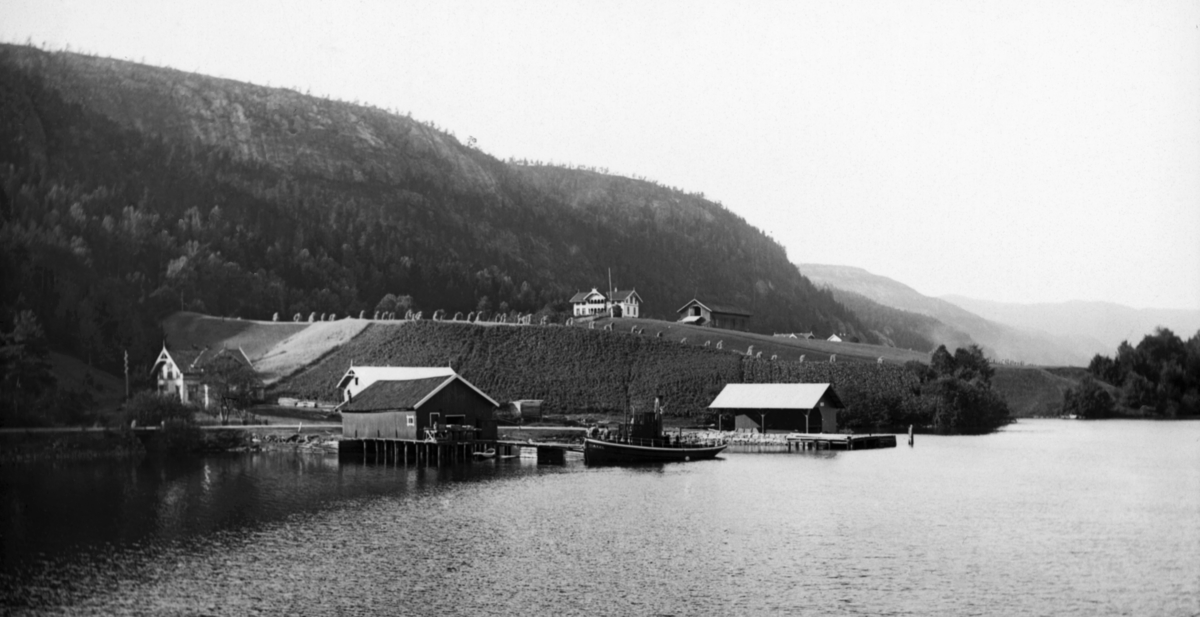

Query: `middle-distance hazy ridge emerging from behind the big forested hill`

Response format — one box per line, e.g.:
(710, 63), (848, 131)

(798, 264), (1091, 365)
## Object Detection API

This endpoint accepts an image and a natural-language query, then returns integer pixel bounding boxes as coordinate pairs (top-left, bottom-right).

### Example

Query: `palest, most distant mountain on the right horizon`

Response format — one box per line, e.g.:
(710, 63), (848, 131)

(942, 295), (1200, 355)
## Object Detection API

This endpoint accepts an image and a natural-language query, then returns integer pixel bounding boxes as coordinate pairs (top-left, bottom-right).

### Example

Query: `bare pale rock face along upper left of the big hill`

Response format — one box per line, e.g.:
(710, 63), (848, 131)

(12, 49), (496, 191)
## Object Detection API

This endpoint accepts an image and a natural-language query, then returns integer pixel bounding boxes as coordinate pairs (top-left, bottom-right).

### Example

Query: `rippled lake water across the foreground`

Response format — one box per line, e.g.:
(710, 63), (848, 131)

(0, 420), (1200, 616)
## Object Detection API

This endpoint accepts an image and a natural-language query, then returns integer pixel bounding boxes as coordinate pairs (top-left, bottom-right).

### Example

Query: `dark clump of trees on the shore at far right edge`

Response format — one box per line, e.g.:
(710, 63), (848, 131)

(1080, 328), (1200, 418)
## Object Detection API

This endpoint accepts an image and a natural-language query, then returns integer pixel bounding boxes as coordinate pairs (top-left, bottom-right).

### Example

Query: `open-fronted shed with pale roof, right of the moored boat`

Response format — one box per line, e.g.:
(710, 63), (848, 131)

(708, 383), (844, 433)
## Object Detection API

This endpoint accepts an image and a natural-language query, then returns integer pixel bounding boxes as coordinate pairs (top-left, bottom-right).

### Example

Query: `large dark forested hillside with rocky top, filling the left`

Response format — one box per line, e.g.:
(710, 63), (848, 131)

(0, 46), (875, 377)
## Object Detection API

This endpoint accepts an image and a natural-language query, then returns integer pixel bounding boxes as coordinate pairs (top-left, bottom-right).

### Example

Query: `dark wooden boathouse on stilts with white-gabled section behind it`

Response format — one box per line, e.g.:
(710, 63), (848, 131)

(337, 366), (499, 441)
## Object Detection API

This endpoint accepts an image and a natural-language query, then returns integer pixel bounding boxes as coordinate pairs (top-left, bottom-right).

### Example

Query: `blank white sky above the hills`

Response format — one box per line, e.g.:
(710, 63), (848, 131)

(0, 0), (1200, 309)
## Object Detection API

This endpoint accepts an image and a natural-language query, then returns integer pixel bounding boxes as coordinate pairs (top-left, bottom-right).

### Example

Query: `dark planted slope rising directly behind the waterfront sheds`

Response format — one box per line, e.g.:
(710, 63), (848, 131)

(272, 322), (917, 417)
